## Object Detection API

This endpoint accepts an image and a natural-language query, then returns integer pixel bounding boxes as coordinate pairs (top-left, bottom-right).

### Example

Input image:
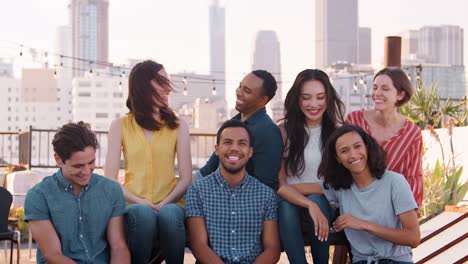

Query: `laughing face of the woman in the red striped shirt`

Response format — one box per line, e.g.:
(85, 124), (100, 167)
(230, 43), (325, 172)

(371, 74), (405, 111)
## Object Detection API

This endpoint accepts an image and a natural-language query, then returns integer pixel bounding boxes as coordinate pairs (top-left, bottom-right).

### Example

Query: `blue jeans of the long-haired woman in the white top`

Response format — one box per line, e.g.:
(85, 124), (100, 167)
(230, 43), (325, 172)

(278, 194), (334, 264)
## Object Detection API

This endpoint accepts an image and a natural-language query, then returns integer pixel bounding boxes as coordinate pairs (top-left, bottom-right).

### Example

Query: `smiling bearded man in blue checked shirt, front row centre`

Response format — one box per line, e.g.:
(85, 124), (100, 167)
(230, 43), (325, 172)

(185, 120), (280, 264)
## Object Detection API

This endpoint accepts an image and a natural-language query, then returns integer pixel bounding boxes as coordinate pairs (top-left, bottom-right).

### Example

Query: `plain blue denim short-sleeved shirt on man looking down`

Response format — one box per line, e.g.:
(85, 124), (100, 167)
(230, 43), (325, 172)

(25, 169), (125, 264)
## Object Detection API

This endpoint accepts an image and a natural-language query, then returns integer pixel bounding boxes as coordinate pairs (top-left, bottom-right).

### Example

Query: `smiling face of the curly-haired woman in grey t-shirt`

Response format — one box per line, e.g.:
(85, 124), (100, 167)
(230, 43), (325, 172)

(335, 131), (369, 175)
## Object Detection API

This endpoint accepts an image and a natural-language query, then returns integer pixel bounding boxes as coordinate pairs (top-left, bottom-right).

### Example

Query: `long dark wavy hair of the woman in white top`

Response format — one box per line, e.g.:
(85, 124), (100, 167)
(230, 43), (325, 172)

(284, 69), (344, 176)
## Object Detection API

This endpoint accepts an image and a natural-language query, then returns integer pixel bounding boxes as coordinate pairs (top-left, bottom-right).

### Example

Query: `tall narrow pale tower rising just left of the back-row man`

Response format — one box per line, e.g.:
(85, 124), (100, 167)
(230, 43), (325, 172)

(209, 0), (226, 100)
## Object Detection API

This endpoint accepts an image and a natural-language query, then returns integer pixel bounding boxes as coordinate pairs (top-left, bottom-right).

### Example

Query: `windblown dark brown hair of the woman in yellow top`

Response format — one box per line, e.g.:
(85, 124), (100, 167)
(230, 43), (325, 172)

(127, 60), (179, 131)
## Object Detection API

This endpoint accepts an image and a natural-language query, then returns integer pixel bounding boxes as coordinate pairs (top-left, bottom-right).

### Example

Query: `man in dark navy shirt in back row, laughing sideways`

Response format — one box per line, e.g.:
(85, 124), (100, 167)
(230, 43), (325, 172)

(195, 70), (283, 190)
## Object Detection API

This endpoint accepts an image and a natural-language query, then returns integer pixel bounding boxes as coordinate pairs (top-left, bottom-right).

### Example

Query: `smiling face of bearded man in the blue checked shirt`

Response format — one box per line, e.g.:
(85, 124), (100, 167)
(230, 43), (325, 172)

(215, 127), (253, 174)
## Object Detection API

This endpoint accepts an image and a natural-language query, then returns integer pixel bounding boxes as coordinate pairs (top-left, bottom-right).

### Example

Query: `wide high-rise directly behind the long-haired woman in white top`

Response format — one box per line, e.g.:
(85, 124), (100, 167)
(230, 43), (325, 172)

(315, 0), (359, 69)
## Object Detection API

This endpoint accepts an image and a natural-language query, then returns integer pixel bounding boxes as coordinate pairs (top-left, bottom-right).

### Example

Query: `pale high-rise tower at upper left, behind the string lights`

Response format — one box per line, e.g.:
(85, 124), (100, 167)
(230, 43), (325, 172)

(68, 0), (109, 76)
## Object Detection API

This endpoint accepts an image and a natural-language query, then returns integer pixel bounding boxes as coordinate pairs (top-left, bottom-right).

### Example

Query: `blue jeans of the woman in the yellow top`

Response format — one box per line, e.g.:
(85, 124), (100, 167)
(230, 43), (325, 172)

(125, 204), (185, 264)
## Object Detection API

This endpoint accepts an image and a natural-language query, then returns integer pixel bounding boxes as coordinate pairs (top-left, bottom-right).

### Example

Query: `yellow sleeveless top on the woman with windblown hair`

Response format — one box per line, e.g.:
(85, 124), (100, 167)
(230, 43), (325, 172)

(121, 114), (184, 206)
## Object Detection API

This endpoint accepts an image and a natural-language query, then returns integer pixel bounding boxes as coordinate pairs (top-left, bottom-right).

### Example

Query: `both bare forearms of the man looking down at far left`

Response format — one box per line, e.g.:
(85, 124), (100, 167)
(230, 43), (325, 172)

(29, 216), (130, 264)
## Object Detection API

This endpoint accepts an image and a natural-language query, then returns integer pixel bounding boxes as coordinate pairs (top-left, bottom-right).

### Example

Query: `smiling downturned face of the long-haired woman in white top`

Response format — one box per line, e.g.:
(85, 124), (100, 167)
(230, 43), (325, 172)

(299, 80), (327, 127)
